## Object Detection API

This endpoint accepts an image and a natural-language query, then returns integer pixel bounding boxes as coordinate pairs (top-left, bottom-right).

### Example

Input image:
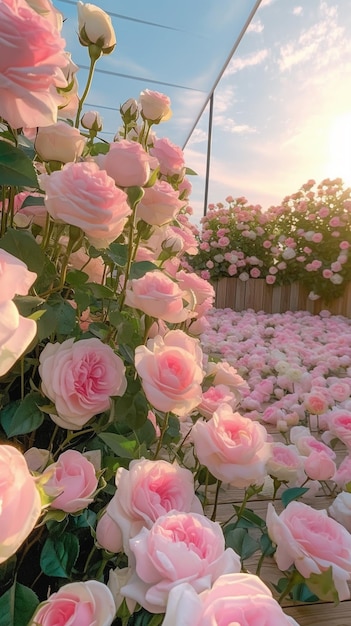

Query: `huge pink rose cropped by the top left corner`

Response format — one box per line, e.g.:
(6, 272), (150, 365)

(0, 0), (67, 128)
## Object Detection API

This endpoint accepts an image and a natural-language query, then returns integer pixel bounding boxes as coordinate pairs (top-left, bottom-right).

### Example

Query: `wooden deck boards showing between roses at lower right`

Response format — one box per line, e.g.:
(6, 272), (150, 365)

(206, 433), (351, 626)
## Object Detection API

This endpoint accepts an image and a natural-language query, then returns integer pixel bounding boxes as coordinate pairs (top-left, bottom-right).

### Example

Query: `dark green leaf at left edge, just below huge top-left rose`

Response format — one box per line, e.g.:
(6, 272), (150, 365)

(0, 141), (38, 188)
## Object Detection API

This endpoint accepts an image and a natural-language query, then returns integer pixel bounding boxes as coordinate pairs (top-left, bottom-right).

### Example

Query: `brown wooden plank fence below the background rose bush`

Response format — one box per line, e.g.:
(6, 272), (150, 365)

(213, 278), (351, 318)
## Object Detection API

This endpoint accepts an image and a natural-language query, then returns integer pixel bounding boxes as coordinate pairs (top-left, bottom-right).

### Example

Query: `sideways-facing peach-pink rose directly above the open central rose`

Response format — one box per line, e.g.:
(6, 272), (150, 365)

(125, 270), (192, 324)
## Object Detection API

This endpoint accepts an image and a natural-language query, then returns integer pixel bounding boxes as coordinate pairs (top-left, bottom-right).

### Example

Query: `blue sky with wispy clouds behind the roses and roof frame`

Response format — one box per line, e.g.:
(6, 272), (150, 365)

(54, 0), (351, 221)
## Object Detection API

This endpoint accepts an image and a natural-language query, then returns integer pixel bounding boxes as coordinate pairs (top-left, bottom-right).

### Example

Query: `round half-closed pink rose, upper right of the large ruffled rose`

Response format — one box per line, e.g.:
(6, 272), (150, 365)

(100, 139), (151, 187)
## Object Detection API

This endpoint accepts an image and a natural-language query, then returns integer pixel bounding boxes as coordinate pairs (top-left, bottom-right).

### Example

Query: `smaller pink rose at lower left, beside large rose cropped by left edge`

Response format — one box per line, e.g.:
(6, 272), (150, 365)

(43, 450), (98, 513)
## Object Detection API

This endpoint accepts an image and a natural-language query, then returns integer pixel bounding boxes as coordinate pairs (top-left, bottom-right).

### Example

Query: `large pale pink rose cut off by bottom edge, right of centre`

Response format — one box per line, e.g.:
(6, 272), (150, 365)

(162, 572), (298, 626)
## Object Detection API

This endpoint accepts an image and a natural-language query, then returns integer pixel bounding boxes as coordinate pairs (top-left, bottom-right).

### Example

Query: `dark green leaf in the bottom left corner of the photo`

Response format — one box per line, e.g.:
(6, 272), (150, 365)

(0, 583), (39, 626)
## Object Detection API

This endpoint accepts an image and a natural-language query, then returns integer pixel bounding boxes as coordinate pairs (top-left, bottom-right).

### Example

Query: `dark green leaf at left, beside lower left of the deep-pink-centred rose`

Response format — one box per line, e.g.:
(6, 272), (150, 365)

(5, 391), (47, 437)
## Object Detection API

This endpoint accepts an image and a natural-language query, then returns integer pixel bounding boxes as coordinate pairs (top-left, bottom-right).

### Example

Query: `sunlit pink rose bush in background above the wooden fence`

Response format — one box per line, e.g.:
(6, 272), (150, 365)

(188, 178), (351, 300)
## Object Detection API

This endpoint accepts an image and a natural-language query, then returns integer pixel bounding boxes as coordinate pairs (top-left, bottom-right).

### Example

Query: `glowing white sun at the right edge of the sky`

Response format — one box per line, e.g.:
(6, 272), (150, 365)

(329, 111), (351, 186)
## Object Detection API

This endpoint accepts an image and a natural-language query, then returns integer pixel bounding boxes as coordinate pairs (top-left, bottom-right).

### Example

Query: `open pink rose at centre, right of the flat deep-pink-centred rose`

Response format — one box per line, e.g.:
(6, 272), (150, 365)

(135, 330), (203, 417)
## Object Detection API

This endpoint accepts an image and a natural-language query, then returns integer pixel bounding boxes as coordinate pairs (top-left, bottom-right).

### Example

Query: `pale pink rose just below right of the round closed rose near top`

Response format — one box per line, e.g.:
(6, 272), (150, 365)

(137, 180), (184, 226)
